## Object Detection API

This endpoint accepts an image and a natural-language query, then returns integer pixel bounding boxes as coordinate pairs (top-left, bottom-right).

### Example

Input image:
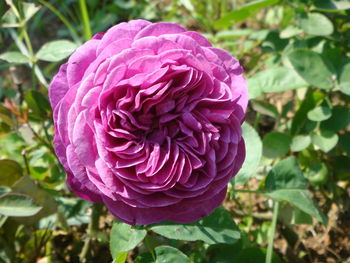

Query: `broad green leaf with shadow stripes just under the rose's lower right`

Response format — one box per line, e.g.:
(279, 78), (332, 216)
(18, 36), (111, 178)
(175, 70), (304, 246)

(151, 207), (240, 244)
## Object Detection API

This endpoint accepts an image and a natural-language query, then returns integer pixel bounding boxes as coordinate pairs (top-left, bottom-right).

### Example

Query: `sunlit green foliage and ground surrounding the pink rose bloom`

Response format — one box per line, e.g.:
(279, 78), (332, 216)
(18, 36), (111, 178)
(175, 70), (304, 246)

(0, 0), (350, 263)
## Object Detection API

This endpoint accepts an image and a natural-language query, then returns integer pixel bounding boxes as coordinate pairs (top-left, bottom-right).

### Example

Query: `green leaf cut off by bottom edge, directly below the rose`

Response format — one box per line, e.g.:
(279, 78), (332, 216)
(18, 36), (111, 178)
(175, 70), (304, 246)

(154, 246), (190, 263)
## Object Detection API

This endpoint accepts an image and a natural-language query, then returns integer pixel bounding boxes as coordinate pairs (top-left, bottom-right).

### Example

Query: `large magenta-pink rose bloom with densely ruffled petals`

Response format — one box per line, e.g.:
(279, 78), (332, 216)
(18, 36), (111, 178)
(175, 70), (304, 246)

(49, 20), (248, 224)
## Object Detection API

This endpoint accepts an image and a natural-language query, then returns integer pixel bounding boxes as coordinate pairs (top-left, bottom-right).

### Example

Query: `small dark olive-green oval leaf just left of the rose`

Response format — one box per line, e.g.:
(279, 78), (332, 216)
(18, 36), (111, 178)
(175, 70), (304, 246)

(24, 90), (51, 116)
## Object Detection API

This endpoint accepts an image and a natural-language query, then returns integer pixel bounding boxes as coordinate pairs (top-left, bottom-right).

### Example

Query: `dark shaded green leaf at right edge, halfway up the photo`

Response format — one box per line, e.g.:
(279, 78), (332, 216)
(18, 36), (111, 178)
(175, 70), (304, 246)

(320, 106), (350, 132)
